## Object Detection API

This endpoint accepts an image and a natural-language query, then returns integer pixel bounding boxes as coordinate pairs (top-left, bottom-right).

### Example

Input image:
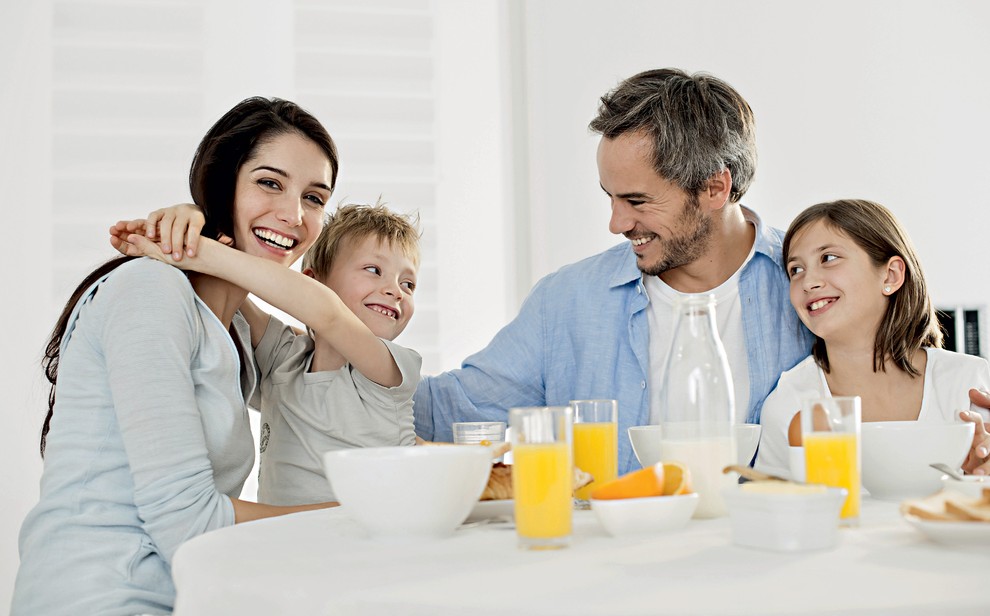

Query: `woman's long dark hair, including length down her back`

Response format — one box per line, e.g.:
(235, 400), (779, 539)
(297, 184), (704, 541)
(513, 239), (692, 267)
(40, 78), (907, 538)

(41, 96), (339, 457)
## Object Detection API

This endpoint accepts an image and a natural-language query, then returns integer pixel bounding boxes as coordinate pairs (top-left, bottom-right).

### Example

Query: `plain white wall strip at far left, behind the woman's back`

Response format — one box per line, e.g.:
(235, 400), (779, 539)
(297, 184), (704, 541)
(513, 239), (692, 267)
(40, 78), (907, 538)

(0, 2), (50, 614)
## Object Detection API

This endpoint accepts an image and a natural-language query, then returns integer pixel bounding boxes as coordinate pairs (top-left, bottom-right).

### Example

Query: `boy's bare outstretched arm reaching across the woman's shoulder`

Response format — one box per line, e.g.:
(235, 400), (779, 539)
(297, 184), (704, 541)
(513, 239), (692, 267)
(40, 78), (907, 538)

(124, 234), (402, 387)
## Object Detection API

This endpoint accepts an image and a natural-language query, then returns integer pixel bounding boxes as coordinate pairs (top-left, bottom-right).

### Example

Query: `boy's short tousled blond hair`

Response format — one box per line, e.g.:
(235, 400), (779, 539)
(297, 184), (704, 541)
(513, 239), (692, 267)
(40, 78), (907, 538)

(303, 201), (419, 278)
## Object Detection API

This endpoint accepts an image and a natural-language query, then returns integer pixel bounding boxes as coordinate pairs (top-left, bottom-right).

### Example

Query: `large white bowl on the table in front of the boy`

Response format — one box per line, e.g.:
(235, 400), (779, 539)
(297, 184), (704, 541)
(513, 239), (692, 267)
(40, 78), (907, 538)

(323, 447), (492, 537)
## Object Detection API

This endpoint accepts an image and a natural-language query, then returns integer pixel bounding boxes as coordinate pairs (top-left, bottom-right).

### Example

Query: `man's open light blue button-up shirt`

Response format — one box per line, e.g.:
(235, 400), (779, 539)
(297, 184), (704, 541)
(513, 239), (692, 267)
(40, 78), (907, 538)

(414, 210), (814, 473)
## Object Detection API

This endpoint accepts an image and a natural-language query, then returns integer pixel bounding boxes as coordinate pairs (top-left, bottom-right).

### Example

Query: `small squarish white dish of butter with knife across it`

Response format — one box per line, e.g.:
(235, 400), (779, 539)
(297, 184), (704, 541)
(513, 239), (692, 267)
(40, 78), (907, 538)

(722, 484), (846, 552)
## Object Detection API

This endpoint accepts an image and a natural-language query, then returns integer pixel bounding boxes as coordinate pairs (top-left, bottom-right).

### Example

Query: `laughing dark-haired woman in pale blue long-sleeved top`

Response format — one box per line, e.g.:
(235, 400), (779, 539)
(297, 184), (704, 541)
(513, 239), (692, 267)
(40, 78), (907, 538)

(12, 98), (337, 614)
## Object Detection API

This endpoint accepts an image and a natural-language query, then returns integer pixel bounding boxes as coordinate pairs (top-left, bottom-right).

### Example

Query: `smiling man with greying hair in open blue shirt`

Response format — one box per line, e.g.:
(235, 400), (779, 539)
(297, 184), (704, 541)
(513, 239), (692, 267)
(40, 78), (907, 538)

(414, 69), (812, 472)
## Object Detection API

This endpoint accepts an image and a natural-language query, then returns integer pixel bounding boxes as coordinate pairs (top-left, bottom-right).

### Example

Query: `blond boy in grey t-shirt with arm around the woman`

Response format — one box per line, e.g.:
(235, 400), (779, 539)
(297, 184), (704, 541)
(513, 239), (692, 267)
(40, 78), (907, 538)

(119, 205), (422, 504)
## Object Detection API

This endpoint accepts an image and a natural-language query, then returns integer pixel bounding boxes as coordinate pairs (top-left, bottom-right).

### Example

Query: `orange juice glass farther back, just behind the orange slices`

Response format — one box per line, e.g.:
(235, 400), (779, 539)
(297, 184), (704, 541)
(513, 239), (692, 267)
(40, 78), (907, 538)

(571, 400), (619, 509)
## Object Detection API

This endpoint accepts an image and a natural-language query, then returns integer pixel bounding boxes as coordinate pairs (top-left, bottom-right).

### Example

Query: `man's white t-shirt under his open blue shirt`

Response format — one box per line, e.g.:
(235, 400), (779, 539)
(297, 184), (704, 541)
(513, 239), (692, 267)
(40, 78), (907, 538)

(643, 230), (756, 424)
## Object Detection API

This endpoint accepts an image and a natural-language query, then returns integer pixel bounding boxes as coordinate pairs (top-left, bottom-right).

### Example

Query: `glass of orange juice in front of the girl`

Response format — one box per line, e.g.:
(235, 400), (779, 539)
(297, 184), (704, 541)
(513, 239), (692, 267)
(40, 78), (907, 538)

(801, 396), (862, 526)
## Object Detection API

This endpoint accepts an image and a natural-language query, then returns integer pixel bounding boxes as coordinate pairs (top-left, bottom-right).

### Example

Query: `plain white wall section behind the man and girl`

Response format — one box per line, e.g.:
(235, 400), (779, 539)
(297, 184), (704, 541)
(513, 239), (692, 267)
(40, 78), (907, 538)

(525, 0), (990, 318)
